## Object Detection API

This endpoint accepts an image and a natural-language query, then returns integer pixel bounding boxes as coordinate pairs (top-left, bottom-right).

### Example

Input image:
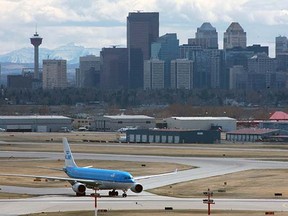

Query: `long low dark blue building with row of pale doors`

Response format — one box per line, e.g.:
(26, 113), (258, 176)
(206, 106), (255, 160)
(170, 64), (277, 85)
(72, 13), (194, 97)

(126, 129), (221, 143)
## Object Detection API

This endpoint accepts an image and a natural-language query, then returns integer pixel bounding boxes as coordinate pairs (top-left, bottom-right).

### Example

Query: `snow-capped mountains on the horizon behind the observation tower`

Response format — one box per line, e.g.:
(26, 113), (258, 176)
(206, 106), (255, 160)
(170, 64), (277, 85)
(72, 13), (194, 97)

(0, 43), (100, 64)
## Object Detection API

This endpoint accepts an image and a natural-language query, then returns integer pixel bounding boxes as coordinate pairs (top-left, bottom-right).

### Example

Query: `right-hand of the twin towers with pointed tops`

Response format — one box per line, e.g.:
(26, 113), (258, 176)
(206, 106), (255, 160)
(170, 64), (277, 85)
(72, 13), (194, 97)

(223, 22), (247, 50)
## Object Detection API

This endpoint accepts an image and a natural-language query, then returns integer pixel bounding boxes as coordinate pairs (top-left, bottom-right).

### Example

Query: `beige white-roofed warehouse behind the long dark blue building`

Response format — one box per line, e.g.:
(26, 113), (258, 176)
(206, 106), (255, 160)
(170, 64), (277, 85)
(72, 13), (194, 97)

(164, 117), (236, 131)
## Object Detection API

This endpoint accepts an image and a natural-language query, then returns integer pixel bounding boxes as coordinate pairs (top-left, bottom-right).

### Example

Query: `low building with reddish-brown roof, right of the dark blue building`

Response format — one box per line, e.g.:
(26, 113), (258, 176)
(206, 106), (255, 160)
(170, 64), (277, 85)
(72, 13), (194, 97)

(226, 128), (285, 142)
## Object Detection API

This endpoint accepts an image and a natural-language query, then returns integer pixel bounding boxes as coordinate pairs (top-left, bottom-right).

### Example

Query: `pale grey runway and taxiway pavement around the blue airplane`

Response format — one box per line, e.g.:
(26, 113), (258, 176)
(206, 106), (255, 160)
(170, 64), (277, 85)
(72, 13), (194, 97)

(0, 151), (288, 216)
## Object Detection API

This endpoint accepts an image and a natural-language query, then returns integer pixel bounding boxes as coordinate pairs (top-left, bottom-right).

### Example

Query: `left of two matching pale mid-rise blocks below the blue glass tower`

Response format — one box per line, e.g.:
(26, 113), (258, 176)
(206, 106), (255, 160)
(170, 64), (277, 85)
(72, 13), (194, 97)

(144, 59), (165, 89)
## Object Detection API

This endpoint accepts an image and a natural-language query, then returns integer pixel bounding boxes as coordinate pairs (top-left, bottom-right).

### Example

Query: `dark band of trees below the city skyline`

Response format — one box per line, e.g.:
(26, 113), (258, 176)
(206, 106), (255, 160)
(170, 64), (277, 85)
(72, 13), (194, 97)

(1, 88), (288, 108)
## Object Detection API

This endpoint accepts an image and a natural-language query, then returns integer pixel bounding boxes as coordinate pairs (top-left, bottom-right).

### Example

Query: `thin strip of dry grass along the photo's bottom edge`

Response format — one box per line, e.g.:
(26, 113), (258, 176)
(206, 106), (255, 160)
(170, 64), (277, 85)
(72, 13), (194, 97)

(25, 210), (287, 216)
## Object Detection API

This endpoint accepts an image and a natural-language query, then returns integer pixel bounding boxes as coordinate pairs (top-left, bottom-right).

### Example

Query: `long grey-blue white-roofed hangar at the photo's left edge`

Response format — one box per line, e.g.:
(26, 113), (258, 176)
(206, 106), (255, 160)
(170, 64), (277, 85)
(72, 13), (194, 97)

(0, 115), (72, 132)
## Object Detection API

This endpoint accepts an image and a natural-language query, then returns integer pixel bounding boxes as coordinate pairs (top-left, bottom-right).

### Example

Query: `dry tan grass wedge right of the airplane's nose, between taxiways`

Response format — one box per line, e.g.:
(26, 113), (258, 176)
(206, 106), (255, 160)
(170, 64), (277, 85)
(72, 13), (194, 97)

(150, 169), (288, 199)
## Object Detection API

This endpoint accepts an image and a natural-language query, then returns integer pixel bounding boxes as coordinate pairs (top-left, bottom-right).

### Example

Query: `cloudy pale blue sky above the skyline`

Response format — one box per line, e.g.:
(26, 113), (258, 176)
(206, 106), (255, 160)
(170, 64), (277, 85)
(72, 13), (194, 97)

(0, 0), (288, 57)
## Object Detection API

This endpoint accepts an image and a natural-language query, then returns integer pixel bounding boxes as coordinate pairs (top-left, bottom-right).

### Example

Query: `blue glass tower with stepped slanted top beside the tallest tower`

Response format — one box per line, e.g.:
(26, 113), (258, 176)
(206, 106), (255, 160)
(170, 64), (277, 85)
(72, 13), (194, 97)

(151, 33), (179, 88)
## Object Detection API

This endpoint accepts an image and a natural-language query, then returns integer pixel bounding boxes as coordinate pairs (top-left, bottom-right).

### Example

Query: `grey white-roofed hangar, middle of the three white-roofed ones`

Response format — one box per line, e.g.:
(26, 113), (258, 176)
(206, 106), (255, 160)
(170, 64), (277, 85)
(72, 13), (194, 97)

(91, 115), (156, 131)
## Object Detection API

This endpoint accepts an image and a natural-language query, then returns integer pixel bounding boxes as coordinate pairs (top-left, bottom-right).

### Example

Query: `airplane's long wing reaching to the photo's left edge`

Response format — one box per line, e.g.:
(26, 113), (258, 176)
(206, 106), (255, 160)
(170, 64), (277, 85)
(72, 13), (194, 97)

(0, 173), (101, 186)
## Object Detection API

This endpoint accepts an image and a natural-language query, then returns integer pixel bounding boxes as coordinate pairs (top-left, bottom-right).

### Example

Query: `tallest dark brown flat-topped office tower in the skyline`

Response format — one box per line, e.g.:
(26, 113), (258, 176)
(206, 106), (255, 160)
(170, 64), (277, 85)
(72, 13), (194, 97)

(127, 12), (159, 88)
